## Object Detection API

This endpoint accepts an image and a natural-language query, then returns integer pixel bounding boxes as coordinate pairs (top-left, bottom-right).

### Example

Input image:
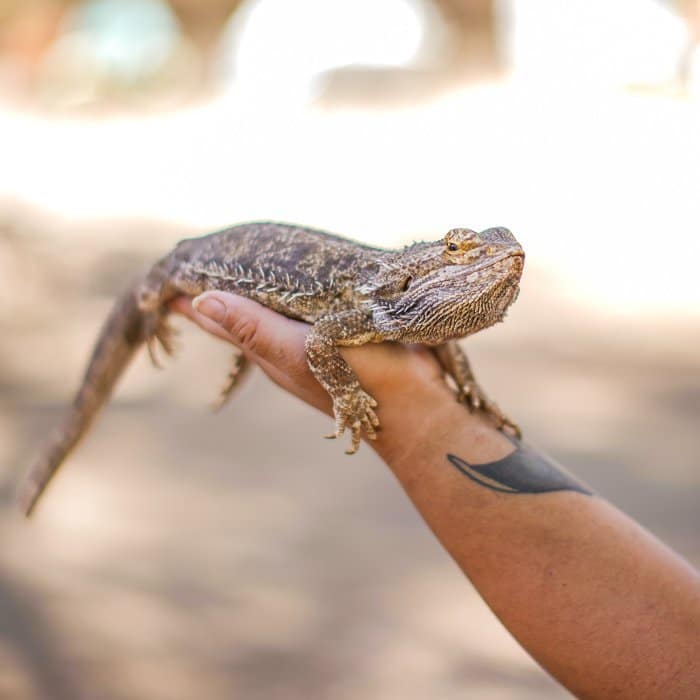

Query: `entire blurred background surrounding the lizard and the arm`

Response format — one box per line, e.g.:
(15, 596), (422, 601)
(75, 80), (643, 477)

(0, 0), (700, 700)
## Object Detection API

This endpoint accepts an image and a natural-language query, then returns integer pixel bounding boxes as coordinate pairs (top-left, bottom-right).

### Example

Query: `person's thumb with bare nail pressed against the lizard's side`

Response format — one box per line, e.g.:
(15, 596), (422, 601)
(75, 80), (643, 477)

(192, 291), (308, 364)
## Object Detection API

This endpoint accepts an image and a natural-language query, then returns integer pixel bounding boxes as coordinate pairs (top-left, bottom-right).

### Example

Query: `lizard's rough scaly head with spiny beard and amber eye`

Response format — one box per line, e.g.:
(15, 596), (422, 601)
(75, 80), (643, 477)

(360, 228), (525, 345)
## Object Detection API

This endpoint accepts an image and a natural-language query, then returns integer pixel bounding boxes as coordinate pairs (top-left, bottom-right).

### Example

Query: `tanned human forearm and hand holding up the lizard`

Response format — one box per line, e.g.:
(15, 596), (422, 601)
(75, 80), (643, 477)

(175, 293), (700, 700)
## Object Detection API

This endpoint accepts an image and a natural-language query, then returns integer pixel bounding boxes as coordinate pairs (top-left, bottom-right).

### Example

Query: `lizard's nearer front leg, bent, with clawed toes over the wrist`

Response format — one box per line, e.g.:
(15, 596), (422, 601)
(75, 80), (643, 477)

(304, 309), (379, 454)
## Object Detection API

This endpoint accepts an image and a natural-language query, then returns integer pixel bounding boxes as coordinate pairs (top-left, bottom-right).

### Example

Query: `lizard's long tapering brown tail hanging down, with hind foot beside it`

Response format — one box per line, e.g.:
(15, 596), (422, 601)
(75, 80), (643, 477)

(19, 285), (170, 516)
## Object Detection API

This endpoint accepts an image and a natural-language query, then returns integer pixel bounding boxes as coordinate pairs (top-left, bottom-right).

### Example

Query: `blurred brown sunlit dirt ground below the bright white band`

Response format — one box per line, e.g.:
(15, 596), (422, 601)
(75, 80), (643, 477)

(0, 215), (700, 700)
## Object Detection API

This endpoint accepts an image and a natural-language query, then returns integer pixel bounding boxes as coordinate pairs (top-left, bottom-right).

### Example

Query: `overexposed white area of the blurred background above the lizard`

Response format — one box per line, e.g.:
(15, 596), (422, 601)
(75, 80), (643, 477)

(0, 0), (700, 316)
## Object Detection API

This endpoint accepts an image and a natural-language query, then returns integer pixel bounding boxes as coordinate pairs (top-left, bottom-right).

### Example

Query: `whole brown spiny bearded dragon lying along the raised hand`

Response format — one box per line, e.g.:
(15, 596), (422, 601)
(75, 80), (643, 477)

(20, 222), (524, 515)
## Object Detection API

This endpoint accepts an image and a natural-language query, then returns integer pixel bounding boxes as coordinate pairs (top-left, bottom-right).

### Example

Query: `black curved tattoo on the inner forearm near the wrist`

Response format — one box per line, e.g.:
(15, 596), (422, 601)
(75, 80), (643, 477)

(447, 441), (593, 496)
